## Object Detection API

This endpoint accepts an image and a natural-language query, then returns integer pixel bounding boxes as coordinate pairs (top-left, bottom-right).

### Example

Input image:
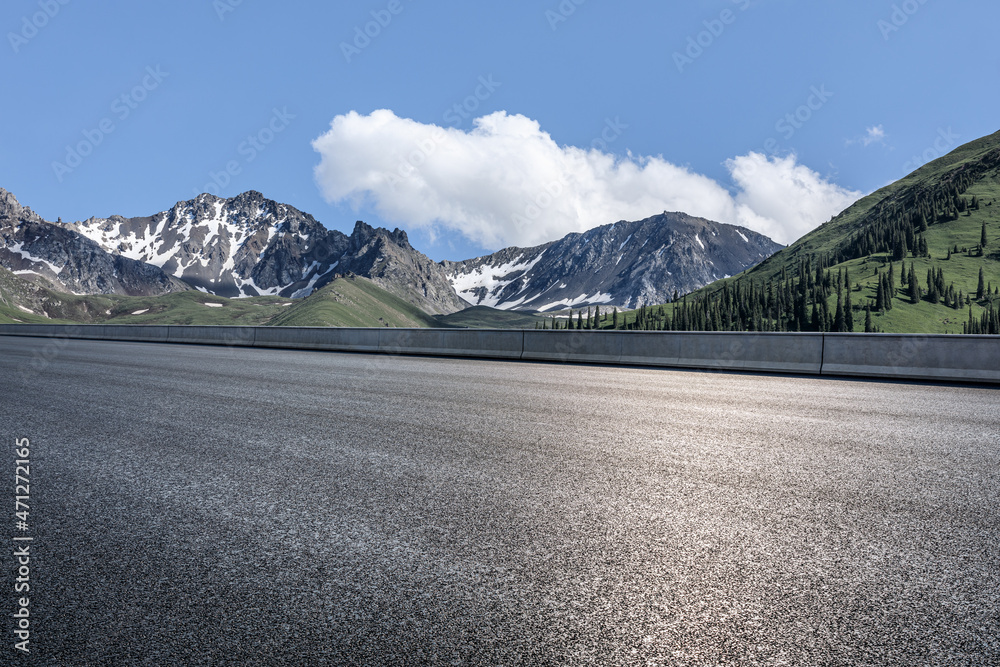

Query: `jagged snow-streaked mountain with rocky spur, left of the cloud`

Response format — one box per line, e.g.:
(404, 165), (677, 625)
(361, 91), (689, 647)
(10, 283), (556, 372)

(64, 191), (466, 314)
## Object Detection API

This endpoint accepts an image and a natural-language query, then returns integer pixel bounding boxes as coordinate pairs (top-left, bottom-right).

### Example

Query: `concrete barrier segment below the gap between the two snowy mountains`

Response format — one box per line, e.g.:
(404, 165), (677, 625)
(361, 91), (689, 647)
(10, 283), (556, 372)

(378, 328), (524, 359)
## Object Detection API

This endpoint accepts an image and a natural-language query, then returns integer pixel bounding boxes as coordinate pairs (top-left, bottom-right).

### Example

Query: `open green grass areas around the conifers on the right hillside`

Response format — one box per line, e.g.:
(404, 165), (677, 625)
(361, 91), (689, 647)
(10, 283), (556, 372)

(627, 132), (1000, 333)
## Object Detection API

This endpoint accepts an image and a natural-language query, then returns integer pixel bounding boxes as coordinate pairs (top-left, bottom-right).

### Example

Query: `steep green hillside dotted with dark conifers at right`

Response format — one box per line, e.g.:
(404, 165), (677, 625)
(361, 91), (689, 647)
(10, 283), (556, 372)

(623, 132), (1000, 333)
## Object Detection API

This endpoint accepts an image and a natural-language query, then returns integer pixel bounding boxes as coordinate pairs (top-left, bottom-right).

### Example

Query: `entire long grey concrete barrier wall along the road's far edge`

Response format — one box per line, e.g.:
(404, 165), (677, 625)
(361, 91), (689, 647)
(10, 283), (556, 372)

(0, 324), (1000, 384)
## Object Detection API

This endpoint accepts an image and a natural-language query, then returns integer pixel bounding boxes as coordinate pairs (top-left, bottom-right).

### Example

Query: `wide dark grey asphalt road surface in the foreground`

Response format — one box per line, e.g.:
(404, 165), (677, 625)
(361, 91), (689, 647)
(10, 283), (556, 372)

(0, 337), (1000, 665)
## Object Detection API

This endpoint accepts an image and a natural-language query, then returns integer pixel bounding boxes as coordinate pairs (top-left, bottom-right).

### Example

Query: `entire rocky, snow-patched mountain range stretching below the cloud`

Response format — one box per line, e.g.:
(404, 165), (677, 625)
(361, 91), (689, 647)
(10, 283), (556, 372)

(0, 189), (781, 314)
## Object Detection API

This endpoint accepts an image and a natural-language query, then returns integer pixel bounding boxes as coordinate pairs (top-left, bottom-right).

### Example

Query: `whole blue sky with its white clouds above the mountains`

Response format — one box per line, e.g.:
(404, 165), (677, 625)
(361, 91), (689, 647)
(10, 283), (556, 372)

(0, 0), (1000, 259)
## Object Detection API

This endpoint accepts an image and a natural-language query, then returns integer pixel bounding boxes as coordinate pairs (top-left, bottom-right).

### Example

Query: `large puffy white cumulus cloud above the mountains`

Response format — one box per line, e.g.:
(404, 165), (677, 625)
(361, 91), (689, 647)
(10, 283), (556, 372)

(313, 110), (860, 249)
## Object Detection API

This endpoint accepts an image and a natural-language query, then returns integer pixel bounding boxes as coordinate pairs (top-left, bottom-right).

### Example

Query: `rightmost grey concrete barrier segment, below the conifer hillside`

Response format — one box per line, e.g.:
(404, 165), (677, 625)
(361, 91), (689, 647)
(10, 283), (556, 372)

(823, 334), (1000, 383)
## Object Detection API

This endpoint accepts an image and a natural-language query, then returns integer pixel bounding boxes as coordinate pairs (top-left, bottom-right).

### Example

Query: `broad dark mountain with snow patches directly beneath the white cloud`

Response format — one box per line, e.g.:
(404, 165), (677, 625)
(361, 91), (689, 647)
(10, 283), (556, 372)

(442, 212), (783, 312)
